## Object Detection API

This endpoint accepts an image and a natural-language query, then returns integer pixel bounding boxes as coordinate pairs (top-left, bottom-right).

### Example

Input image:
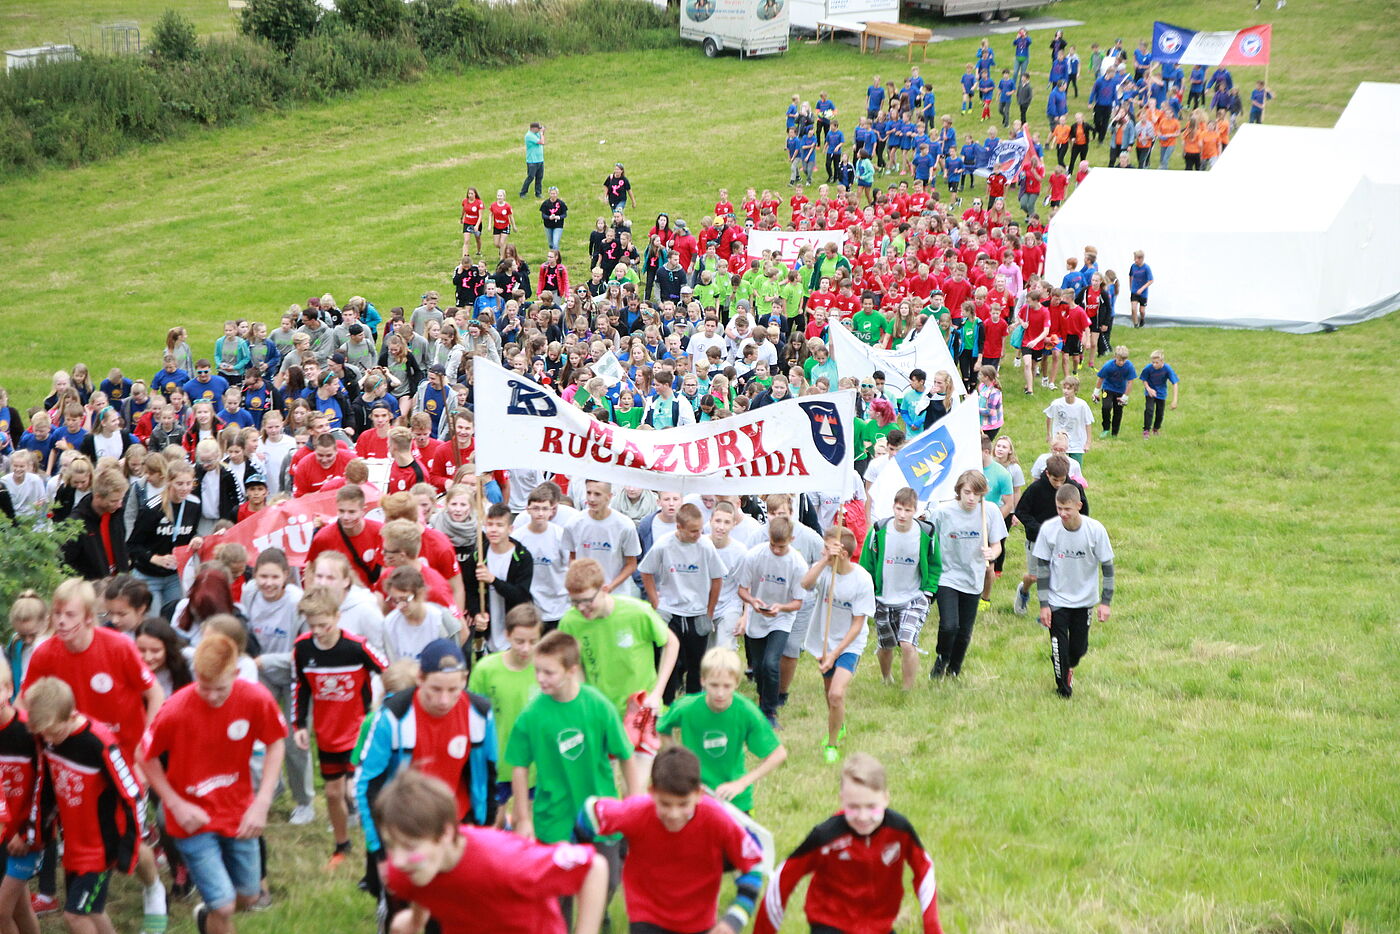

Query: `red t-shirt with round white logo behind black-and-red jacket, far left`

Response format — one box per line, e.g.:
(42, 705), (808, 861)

(24, 627), (155, 760)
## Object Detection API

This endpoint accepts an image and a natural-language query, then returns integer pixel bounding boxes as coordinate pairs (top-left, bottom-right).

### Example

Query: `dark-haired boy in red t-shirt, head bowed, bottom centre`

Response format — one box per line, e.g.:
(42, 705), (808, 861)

(581, 746), (771, 934)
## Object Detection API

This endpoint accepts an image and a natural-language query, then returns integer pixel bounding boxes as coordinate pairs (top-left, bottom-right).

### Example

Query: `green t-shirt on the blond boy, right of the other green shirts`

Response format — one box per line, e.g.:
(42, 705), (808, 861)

(657, 695), (778, 811)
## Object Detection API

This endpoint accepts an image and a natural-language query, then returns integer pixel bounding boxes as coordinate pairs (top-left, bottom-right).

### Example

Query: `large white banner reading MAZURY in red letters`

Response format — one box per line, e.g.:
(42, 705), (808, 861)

(473, 360), (855, 493)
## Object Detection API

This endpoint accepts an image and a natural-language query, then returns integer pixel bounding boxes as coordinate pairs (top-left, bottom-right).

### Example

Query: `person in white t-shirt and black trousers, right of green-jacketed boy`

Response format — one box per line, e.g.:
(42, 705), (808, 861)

(929, 471), (1007, 681)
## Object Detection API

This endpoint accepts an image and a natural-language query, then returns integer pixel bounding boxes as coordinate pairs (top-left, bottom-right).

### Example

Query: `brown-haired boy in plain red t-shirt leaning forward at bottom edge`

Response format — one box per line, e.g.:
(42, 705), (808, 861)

(374, 770), (608, 934)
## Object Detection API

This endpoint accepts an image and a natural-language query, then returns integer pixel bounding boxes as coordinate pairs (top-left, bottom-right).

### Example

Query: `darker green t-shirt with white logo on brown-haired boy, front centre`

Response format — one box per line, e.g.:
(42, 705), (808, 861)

(505, 685), (631, 843)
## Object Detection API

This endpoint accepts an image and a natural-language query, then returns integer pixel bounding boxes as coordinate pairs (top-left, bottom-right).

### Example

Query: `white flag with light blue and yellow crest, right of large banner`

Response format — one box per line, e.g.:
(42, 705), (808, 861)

(867, 399), (981, 522)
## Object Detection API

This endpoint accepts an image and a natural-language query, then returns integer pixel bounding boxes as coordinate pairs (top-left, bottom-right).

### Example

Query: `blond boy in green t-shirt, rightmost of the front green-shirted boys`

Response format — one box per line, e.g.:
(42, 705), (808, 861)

(657, 646), (787, 812)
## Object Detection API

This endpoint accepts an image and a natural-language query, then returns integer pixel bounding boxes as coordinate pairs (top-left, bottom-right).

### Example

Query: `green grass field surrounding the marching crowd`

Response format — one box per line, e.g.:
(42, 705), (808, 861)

(0, 0), (1400, 934)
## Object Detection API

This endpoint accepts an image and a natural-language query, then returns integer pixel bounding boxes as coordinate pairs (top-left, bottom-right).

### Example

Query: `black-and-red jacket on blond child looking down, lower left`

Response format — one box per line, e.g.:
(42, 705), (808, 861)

(41, 722), (141, 875)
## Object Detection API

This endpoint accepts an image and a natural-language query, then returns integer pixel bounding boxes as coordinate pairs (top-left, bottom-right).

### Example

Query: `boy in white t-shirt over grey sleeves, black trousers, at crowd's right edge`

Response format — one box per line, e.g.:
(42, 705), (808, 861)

(1035, 483), (1113, 697)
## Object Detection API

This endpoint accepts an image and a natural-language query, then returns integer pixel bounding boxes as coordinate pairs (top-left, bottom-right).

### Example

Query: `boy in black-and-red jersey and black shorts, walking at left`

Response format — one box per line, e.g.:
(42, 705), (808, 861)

(291, 587), (389, 868)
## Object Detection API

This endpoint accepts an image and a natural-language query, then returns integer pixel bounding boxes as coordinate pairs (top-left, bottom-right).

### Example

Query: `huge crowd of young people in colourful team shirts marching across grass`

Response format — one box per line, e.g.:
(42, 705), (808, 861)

(0, 18), (1209, 934)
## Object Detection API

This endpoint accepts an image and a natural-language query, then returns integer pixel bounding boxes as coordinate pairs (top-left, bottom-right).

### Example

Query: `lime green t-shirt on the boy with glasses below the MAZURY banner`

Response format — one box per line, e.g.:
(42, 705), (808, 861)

(559, 595), (671, 714)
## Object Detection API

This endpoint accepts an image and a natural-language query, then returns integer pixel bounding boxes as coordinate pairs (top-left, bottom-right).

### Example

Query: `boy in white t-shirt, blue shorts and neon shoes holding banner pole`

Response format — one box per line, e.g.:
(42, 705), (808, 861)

(802, 525), (875, 763)
